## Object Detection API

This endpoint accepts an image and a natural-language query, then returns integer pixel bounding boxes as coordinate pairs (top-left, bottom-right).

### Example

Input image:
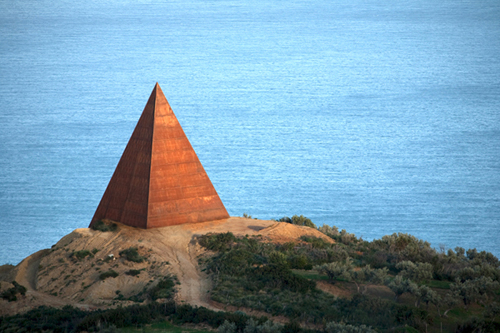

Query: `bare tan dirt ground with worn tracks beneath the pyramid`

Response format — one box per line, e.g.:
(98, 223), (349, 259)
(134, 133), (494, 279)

(0, 217), (332, 316)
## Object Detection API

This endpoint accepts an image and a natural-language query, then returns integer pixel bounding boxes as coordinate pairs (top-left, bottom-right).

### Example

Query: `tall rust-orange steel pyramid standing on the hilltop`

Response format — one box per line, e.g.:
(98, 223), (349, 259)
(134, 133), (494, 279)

(90, 83), (229, 229)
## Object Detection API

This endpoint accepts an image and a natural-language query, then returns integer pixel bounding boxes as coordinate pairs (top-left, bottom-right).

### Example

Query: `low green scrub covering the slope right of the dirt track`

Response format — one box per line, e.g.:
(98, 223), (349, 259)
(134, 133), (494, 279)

(199, 215), (500, 332)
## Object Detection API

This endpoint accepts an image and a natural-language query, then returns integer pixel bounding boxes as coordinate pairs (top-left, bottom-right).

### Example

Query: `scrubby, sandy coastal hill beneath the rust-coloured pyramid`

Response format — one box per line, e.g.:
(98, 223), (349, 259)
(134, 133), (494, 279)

(0, 215), (500, 333)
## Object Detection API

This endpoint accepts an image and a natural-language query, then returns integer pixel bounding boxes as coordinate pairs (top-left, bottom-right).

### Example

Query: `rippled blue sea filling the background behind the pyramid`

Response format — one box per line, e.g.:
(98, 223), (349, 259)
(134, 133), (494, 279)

(0, 0), (500, 264)
